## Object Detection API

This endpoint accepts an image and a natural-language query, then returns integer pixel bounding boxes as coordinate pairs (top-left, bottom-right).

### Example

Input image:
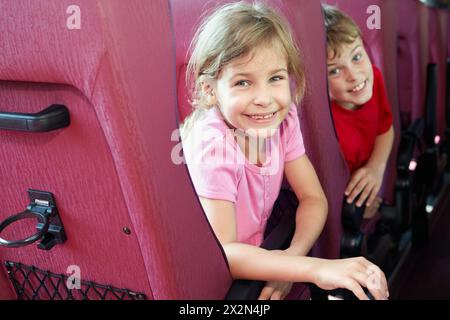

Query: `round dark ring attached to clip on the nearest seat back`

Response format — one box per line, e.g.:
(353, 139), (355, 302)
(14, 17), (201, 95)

(0, 210), (50, 248)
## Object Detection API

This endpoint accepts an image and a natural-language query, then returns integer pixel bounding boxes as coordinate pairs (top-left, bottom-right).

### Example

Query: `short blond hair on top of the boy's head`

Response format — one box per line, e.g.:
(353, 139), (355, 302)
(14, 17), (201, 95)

(322, 5), (361, 59)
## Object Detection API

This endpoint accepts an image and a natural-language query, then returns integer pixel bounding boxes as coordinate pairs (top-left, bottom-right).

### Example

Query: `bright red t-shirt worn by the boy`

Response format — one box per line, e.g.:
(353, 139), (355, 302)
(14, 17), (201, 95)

(331, 66), (392, 173)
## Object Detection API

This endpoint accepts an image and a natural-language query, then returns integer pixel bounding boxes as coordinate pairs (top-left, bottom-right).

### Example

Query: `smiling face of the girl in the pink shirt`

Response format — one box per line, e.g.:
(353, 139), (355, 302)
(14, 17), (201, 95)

(207, 42), (291, 137)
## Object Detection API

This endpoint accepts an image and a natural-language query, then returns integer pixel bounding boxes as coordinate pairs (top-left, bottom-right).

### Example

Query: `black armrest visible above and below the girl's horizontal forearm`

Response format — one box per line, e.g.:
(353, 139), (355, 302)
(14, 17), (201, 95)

(225, 190), (298, 300)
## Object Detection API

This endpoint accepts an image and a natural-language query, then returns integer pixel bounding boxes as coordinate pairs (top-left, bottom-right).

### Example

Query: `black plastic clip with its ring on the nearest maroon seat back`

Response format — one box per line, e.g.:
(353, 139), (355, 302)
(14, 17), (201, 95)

(0, 189), (67, 250)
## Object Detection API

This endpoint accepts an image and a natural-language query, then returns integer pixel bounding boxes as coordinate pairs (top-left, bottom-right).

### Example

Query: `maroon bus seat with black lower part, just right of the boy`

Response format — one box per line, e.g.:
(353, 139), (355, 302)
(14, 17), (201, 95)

(397, 0), (435, 244)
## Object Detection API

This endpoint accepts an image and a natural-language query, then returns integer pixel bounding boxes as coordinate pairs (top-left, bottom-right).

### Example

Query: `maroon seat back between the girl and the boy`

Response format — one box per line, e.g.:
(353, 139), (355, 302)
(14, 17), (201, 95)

(269, 0), (349, 259)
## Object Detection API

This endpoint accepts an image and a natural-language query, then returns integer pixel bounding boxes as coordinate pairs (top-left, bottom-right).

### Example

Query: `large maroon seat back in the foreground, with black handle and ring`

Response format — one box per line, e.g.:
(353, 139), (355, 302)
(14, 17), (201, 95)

(0, 0), (231, 299)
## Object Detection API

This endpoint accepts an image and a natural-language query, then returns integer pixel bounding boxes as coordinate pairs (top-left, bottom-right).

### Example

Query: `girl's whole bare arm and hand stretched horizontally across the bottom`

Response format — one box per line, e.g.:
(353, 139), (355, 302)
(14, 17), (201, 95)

(200, 197), (388, 299)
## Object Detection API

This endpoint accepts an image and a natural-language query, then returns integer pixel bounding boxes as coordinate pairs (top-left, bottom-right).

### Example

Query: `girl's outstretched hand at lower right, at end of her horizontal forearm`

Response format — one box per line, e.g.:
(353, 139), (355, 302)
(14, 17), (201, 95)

(313, 257), (389, 300)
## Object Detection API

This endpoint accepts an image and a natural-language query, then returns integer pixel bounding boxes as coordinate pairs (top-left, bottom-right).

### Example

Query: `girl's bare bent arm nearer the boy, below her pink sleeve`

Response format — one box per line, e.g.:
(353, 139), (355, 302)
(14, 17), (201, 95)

(284, 155), (328, 256)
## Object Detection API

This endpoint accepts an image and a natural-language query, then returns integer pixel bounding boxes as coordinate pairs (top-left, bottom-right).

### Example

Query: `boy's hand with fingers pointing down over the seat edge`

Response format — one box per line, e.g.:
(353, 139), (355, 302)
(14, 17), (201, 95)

(345, 166), (384, 207)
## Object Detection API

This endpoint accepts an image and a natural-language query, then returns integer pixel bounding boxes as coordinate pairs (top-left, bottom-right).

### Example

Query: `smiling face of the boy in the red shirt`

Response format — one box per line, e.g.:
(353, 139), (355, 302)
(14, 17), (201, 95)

(328, 37), (373, 110)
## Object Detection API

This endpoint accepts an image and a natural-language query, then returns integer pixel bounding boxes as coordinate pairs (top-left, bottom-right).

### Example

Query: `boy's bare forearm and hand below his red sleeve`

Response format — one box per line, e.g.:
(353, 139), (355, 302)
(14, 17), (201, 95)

(345, 126), (394, 207)
